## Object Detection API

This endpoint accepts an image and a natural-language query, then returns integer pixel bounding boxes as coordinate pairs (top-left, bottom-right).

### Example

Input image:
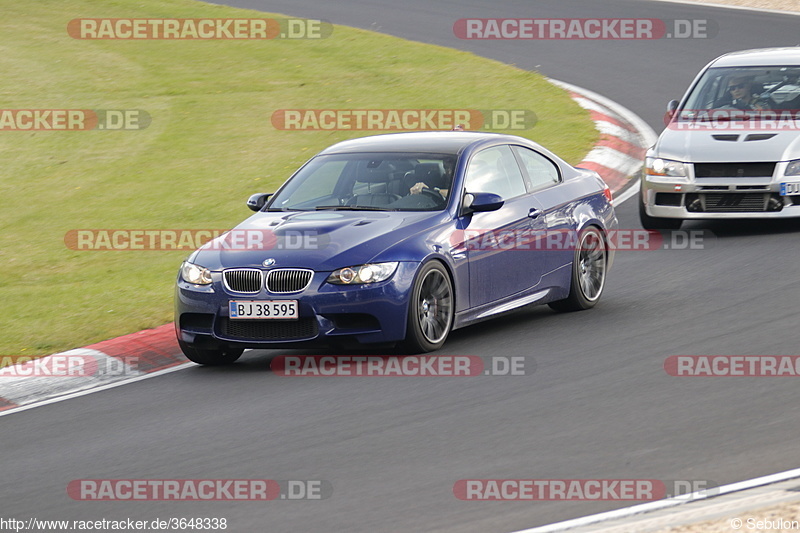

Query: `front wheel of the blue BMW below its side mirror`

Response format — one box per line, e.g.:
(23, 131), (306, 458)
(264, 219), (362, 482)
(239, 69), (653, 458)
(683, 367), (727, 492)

(403, 261), (455, 353)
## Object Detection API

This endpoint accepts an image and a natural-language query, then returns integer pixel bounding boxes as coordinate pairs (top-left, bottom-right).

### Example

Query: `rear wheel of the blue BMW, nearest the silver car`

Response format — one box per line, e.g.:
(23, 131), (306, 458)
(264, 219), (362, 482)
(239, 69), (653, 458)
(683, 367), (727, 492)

(548, 226), (608, 312)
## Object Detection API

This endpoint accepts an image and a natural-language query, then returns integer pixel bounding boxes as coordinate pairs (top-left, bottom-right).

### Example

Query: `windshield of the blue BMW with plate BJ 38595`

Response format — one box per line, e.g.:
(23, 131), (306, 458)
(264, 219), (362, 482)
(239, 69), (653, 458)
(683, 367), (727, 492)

(268, 153), (456, 211)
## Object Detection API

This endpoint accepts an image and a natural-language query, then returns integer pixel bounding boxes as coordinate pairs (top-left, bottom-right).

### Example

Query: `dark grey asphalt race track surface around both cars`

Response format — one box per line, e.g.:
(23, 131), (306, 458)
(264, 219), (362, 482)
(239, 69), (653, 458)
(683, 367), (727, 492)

(0, 0), (800, 532)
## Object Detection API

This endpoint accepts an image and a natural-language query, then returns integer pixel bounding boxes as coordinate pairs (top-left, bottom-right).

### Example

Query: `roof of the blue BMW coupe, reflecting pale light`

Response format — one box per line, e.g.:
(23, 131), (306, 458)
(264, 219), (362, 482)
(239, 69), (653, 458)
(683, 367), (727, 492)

(320, 131), (538, 155)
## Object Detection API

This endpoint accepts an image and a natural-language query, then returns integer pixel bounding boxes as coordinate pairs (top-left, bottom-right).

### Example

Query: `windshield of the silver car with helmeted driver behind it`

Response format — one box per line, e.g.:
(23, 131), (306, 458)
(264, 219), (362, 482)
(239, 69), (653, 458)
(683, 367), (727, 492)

(678, 66), (800, 120)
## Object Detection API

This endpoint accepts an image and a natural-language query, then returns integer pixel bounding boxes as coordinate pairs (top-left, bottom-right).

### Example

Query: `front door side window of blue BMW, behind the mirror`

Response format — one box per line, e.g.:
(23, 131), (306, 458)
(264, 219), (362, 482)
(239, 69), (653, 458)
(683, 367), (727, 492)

(465, 144), (527, 199)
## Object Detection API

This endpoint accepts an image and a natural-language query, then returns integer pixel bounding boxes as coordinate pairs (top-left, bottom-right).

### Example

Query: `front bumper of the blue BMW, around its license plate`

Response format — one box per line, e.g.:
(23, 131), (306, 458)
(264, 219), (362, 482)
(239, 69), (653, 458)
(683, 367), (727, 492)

(175, 262), (419, 349)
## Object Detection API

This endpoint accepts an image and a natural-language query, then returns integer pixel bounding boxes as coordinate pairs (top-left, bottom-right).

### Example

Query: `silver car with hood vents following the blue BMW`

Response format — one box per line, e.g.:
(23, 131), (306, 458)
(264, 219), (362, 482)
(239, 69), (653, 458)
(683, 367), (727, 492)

(639, 47), (800, 229)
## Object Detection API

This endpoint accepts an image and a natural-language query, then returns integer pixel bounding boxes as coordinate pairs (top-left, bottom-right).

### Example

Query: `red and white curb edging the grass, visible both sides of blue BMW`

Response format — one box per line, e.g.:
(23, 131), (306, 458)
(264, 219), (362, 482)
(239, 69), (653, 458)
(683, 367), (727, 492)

(0, 80), (655, 416)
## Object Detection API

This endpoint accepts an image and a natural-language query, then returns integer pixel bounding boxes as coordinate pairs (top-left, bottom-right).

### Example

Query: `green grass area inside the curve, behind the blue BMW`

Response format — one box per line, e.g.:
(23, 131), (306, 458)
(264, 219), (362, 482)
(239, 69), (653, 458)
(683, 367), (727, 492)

(0, 0), (597, 355)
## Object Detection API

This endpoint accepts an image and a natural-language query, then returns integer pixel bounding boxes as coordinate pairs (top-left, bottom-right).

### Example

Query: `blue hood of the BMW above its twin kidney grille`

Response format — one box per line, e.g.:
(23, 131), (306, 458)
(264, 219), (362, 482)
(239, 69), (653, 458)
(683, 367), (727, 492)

(190, 211), (442, 271)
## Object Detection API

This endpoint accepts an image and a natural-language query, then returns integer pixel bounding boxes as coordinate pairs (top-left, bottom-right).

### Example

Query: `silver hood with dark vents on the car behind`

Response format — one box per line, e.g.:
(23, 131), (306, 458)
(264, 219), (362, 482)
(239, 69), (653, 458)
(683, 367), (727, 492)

(655, 128), (800, 163)
